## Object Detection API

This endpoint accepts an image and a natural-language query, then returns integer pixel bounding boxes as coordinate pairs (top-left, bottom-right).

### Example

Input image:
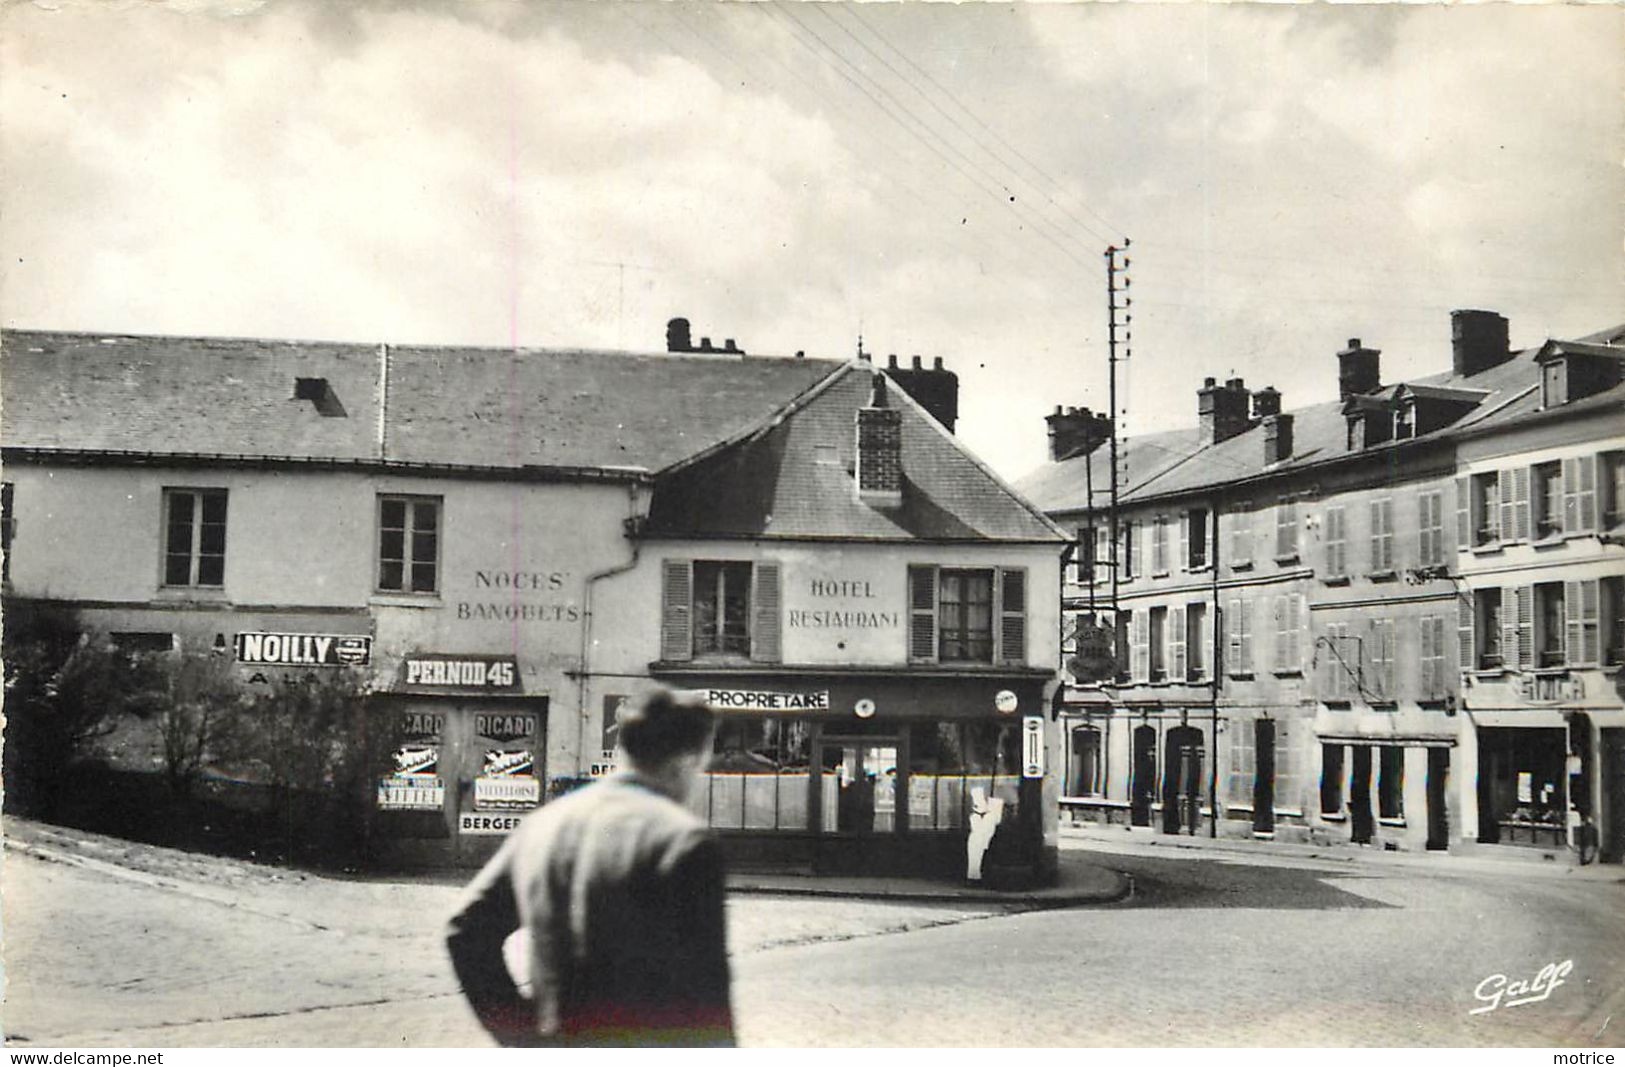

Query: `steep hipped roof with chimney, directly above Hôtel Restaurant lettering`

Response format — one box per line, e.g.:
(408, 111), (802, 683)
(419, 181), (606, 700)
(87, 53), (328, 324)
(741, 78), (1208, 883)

(648, 364), (1064, 542)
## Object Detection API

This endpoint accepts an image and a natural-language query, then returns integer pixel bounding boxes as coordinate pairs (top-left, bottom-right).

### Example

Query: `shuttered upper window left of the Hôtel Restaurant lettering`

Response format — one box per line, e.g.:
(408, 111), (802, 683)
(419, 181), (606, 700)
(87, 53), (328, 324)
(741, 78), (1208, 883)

(660, 559), (782, 663)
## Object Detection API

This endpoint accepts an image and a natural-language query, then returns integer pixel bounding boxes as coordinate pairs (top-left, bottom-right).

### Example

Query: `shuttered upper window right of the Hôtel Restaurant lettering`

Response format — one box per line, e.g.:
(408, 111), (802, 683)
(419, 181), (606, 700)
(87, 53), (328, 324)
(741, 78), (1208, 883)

(908, 565), (1027, 664)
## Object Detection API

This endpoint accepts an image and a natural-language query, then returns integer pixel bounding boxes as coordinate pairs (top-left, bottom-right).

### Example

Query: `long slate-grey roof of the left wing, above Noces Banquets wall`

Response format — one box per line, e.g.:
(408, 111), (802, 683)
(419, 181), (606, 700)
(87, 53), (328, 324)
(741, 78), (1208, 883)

(0, 330), (842, 471)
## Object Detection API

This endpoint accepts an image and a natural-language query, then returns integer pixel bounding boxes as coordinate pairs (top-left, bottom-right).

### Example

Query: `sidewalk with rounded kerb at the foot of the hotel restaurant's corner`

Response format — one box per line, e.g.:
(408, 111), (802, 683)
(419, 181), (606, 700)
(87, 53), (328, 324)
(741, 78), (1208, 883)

(728, 853), (1133, 908)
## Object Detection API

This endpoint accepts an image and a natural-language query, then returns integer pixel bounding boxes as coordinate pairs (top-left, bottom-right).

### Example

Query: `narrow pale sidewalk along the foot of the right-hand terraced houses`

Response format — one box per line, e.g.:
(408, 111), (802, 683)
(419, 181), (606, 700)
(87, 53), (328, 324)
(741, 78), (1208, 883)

(1061, 825), (1625, 883)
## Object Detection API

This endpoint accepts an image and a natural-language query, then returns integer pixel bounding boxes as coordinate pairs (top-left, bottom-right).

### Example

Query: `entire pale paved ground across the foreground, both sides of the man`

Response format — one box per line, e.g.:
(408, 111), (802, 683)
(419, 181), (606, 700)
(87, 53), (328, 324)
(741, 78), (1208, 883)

(3, 818), (1625, 1048)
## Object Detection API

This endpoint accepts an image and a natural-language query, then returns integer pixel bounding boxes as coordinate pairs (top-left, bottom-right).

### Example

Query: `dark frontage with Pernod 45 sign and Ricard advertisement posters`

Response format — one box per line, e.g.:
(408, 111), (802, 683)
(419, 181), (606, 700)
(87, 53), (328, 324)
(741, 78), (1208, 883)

(372, 654), (548, 864)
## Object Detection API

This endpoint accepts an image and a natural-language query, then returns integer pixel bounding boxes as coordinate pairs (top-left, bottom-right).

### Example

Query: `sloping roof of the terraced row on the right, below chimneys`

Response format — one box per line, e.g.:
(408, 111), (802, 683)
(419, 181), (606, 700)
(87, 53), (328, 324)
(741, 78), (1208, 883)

(1016, 319), (1625, 515)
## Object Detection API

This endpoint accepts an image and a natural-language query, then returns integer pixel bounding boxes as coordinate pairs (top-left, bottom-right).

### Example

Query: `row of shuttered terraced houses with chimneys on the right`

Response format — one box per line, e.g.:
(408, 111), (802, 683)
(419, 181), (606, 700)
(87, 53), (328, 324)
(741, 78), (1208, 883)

(1017, 310), (1625, 862)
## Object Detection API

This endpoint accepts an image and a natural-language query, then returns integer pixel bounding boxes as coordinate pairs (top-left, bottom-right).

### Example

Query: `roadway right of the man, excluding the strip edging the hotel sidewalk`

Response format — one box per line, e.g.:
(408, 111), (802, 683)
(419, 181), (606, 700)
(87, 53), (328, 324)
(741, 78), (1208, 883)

(738, 845), (1625, 1046)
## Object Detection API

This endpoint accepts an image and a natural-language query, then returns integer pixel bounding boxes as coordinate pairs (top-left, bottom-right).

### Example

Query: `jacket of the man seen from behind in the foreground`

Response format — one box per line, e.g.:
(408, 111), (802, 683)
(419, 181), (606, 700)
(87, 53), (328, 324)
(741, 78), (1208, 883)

(447, 773), (733, 1044)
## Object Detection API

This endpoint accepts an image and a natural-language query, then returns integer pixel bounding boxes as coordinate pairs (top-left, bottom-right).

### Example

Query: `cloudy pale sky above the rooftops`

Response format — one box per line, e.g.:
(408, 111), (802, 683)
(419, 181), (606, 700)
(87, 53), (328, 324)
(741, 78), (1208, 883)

(0, 0), (1625, 477)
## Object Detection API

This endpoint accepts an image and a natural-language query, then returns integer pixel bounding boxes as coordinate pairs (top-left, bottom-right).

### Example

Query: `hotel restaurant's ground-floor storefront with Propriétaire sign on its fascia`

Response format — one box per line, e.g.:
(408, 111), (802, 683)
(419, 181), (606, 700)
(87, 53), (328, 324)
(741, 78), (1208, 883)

(658, 669), (1053, 877)
